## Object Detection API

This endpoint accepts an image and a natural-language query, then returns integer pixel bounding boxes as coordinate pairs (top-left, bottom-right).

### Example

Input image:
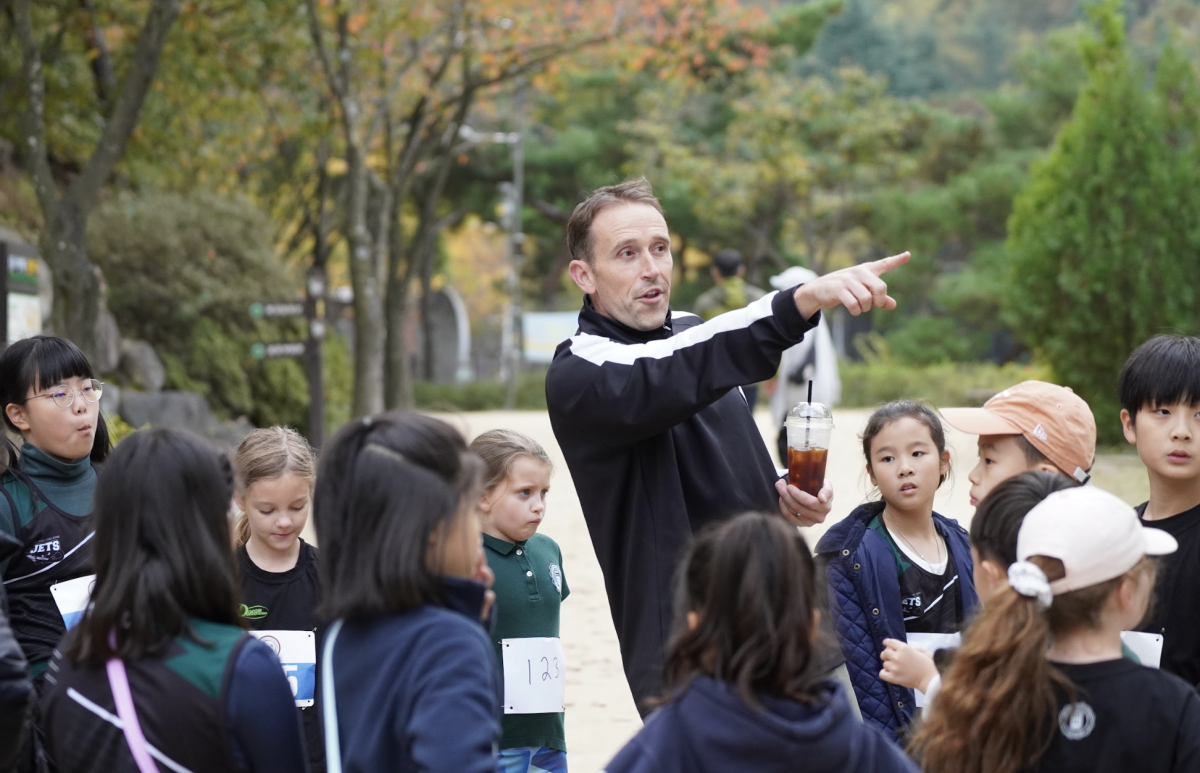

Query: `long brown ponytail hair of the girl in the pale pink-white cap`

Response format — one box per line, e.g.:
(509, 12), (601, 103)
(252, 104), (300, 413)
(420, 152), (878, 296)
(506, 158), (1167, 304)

(910, 556), (1154, 773)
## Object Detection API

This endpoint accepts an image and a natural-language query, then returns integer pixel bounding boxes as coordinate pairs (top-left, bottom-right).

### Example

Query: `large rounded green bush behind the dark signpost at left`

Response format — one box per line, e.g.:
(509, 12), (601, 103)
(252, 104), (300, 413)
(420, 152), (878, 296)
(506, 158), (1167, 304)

(88, 192), (312, 429)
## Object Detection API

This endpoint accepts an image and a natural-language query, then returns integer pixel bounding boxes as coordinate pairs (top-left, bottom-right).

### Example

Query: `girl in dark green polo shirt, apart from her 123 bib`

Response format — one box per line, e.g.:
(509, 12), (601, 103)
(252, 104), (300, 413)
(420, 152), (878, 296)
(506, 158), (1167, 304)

(470, 430), (571, 773)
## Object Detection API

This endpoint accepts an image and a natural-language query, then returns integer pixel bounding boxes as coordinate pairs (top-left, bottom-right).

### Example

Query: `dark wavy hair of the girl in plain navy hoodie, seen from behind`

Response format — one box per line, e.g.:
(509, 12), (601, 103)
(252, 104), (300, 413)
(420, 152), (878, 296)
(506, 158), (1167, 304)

(658, 513), (820, 708)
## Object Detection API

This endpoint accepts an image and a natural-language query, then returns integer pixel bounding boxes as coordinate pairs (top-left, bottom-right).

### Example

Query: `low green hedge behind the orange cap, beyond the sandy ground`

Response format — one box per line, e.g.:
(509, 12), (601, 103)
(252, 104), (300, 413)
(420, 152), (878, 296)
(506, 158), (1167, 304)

(839, 361), (1054, 408)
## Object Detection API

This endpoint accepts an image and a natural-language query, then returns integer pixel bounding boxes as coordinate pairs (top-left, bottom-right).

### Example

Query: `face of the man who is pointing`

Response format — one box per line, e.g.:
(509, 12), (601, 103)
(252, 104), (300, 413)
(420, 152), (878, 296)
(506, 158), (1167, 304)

(570, 204), (671, 330)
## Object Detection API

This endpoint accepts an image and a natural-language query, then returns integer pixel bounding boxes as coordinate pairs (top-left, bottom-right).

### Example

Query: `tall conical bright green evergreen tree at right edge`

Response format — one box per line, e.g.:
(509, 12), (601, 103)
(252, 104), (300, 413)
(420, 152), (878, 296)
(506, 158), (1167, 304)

(1007, 0), (1200, 441)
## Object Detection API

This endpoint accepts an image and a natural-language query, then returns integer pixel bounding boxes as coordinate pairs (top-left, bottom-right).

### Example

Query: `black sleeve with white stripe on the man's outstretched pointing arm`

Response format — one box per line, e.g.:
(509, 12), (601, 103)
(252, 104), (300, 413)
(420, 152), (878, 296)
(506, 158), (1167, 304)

(546, 288), (820, 447)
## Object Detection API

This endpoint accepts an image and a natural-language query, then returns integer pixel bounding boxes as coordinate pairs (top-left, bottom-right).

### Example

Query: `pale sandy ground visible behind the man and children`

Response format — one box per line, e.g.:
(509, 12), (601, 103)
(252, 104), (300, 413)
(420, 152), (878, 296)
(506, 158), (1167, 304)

(307, 409), (1146, 773)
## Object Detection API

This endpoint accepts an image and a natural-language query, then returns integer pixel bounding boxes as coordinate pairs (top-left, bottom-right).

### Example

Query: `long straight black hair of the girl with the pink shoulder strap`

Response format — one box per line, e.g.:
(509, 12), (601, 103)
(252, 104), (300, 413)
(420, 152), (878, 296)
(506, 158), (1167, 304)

(66, 429), (241, 666)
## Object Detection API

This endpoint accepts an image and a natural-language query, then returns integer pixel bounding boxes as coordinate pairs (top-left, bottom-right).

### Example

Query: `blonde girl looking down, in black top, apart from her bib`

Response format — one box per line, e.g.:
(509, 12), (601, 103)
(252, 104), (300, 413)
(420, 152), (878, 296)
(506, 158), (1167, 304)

(233, 427), (325, 773)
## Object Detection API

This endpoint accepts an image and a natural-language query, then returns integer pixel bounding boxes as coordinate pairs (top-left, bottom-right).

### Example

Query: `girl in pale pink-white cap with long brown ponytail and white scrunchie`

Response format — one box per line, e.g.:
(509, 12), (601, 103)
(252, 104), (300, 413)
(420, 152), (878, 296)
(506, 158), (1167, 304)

(911, 486), (1200, 773)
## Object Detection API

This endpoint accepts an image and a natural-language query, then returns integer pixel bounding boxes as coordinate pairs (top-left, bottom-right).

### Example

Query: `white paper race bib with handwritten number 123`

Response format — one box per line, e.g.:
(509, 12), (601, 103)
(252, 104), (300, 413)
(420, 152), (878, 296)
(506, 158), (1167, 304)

(500, 637), (566, 714)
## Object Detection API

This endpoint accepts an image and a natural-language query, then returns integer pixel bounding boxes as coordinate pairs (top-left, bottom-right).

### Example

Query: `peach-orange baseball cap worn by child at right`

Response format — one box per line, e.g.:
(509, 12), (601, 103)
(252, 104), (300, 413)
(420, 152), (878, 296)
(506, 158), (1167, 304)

(941, 382), (1096, 483)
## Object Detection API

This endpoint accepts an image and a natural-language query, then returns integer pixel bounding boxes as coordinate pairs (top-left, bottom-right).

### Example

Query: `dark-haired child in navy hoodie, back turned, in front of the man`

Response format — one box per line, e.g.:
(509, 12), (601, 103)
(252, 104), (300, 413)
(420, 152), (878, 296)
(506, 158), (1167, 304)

(605, 513), (917, 773)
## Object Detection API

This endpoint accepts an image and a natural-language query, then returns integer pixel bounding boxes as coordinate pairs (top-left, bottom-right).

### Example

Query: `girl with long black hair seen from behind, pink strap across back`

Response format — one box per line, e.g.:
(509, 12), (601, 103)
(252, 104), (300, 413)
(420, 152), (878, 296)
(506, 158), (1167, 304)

(42, 430), (308, 773)
